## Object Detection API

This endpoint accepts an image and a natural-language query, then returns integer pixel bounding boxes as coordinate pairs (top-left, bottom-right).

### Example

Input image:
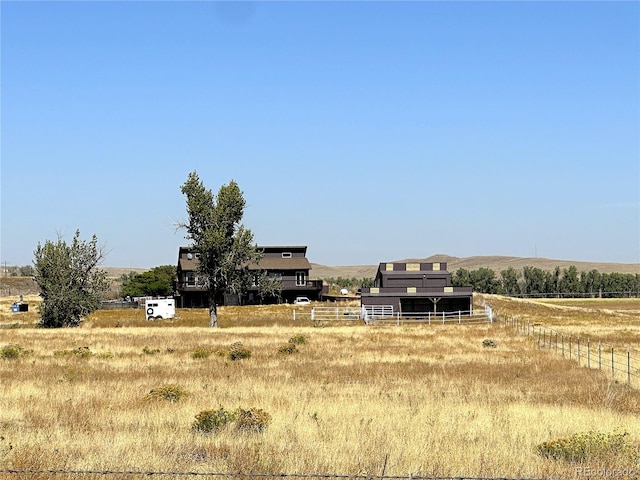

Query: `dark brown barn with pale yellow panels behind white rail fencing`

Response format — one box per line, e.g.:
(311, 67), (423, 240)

(360, 262), (473, 315)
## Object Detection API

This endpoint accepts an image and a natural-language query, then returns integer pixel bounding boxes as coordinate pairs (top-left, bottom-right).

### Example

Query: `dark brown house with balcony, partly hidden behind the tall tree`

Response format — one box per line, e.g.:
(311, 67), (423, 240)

(175, 246), (323, 308)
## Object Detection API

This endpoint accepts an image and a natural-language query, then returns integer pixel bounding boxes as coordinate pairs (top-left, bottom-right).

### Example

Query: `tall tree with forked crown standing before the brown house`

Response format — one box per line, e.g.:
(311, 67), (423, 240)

(178, 171), (260, 327)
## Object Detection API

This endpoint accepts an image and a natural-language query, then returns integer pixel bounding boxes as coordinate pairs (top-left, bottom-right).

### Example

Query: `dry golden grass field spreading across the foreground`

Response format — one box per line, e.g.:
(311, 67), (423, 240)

(0, 297), (640, 479)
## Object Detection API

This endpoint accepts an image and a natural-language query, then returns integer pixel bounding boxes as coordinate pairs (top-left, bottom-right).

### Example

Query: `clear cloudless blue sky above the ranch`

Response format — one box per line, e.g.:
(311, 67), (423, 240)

(0, 0), (640, 268)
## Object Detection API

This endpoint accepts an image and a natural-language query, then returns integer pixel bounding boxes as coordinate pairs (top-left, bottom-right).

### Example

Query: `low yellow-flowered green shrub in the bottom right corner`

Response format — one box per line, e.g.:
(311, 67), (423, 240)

(536, 431), (638, 464)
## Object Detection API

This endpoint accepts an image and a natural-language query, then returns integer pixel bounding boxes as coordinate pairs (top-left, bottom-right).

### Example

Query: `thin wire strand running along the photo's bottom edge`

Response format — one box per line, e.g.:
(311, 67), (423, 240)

(0, 469), (549, 480)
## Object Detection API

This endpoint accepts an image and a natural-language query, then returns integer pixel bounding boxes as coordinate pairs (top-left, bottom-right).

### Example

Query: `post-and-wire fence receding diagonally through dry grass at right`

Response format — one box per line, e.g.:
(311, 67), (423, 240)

(501, 317), (640, 387)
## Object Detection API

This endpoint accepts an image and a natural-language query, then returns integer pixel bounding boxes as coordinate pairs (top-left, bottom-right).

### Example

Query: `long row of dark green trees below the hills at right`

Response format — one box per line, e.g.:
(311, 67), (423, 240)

(451, 265), (640, 298)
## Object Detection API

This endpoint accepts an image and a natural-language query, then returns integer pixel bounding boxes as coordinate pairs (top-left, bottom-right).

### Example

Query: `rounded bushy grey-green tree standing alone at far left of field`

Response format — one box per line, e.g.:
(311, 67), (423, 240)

(34, 230), (109, 328)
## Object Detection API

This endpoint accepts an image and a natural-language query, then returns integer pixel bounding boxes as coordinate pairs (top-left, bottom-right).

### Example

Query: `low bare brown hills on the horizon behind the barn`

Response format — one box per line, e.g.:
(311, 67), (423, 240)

(311, 254), (640, 278)
